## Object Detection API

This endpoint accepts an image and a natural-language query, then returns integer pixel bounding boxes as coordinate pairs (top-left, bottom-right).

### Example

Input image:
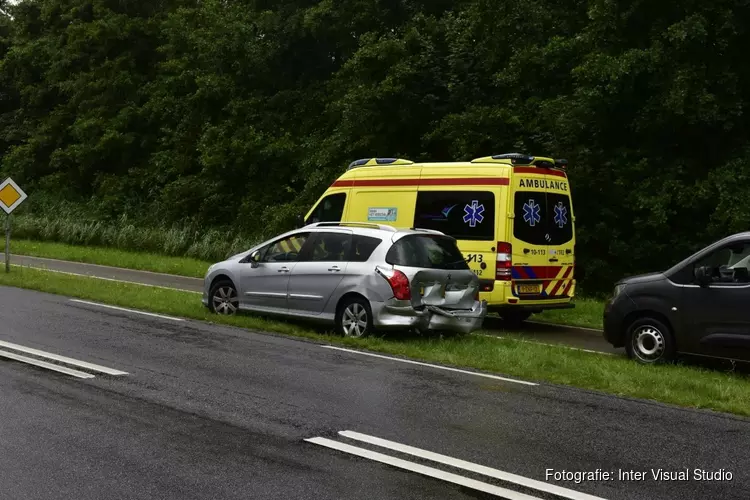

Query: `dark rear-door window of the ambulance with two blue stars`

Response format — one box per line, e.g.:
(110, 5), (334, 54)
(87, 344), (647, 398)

(513, 191), (573, 245)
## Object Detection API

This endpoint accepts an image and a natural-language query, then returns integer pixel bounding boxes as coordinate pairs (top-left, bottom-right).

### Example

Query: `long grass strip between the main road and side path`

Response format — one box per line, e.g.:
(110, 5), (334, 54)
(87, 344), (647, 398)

(0, 267), (750, 416)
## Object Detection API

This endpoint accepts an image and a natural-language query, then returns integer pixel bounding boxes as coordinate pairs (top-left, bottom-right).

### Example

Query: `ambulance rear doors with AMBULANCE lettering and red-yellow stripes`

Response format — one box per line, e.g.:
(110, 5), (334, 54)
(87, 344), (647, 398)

(509, 167), (573, 300)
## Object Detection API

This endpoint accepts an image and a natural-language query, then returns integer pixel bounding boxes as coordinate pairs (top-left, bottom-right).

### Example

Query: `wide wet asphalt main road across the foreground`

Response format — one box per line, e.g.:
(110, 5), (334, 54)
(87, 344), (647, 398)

(0, 287), (750, 500)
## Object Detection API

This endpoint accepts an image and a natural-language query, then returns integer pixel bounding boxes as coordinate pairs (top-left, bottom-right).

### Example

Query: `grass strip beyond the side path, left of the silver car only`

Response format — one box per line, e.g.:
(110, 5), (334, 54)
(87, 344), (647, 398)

(11, 240), (211, 278)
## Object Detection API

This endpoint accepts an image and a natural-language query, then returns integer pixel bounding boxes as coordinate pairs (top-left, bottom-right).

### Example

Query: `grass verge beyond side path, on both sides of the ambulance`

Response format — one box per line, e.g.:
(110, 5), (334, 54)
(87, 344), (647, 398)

(11, 240), (604, 329)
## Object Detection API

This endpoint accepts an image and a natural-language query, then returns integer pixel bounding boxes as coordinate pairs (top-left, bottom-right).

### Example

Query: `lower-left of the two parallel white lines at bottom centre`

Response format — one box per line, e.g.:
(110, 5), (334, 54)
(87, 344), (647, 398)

(305, 437), (541, 500)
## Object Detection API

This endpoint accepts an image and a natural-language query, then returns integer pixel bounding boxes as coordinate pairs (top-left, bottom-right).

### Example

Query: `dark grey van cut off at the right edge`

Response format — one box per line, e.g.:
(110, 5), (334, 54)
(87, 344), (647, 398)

(604, 232), (750, 363)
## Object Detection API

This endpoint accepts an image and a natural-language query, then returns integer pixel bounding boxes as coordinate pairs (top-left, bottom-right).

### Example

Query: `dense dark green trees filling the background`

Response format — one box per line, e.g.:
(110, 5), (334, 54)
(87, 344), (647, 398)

(0, 0), (750, 291)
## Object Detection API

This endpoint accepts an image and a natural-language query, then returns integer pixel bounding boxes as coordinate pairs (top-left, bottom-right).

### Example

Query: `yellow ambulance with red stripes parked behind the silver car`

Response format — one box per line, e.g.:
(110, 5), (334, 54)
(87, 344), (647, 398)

(304, 153), (576, 324)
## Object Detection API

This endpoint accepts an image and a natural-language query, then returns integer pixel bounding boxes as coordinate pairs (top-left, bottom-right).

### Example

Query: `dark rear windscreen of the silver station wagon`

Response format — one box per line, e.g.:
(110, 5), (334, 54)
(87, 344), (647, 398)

(385, 234), (469, 269)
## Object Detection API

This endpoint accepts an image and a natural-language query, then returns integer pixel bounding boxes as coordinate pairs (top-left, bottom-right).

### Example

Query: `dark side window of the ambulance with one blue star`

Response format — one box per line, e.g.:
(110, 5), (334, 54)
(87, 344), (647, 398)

(414, 191), (495, 241)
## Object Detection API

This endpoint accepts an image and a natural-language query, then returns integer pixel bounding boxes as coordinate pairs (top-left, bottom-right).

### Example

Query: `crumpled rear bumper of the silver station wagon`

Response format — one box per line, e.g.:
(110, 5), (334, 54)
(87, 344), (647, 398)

(372, 300), (487, 333)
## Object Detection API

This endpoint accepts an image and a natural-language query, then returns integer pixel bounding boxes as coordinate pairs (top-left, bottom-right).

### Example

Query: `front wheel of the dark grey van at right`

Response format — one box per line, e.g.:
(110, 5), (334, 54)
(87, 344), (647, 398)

(625, 317), (676, 365)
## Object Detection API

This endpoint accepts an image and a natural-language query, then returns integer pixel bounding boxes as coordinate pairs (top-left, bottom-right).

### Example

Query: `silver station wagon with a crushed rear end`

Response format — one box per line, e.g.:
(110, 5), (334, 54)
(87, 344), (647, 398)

(203, 222), (487, 337)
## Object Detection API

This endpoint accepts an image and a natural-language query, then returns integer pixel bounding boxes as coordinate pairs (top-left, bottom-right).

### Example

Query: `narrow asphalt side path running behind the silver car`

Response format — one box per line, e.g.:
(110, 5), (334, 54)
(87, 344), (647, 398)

(11, 255), (625, 354)
